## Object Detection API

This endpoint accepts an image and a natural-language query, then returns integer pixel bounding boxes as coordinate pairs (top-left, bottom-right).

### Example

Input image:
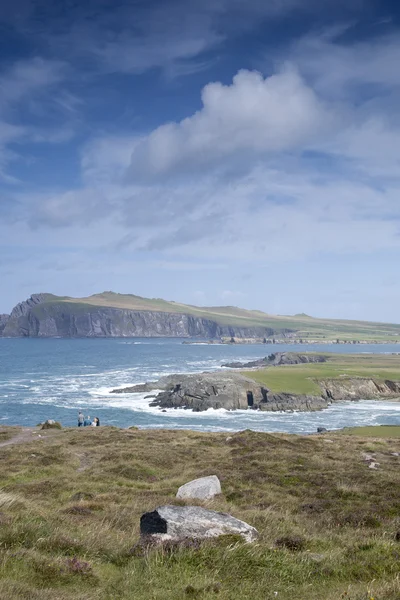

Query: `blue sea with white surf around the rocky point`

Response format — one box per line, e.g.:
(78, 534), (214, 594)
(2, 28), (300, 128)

(0, 338), (400, 433)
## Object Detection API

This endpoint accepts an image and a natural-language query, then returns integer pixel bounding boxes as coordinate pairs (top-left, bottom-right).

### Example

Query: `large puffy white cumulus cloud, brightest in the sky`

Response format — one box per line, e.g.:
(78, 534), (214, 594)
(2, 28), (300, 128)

(126, 68), (332, 180)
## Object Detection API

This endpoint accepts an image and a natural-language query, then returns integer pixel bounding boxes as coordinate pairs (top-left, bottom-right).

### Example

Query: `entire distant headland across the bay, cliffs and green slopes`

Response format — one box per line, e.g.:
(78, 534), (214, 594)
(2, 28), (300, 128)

(0, 291), (400, 342)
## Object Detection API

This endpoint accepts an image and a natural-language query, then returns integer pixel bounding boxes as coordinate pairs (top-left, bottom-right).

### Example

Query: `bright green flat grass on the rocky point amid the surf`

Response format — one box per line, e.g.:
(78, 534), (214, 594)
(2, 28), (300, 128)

(243, 354), (400, 395)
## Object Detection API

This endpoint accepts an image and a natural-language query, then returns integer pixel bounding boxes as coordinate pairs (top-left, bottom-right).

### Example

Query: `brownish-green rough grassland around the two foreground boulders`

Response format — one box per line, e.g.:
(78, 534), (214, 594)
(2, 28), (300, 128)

(0, 428), (400, 600)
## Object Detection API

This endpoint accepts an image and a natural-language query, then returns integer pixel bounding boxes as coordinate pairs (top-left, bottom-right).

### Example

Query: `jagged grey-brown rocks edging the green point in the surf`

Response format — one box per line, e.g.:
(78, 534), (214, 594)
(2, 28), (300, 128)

(111, 353), (400, 412)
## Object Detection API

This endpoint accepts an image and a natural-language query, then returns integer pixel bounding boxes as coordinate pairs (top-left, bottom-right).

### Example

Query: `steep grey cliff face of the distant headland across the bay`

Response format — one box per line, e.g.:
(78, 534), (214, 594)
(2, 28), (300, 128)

(0, 294), (280, 338)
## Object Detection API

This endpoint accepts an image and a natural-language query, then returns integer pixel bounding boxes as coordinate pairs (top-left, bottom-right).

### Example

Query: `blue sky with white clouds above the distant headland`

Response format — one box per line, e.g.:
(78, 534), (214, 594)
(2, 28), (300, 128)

(0, 0), (400, 323)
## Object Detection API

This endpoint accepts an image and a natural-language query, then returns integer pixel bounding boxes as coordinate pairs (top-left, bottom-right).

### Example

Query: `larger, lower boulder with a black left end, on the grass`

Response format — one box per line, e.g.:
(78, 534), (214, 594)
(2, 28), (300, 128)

(140, 506), (258, 542)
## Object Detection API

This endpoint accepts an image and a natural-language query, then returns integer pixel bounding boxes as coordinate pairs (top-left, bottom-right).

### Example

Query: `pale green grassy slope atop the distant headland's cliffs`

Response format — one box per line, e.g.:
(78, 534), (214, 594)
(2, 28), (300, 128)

(28, 292), (400, 341)
